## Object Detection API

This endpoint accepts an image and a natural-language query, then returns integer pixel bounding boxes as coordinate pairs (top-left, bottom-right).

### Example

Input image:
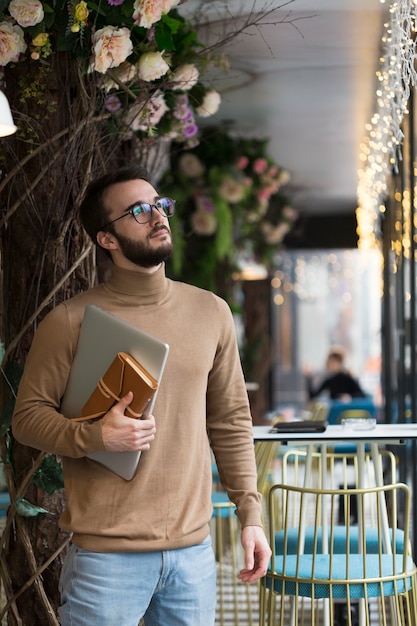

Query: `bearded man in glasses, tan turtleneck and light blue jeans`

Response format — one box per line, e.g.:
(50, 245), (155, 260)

(13, 167), (271, 626)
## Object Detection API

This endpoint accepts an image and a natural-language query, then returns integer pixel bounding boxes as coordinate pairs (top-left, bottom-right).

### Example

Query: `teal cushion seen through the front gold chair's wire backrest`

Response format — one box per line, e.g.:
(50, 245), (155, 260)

(275, 526), (404, 554)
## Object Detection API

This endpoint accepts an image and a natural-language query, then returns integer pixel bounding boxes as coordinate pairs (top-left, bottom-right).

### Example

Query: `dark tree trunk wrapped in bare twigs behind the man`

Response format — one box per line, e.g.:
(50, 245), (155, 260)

(0, 54), (137, 626)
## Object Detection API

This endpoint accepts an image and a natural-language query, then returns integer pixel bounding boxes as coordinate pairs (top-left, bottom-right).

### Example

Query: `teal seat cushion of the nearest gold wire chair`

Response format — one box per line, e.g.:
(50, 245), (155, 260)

(266, 554), (415, 599)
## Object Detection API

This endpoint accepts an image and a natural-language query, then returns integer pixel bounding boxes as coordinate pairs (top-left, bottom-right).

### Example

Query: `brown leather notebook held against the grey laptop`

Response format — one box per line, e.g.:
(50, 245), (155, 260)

(74, 352), (158, 422)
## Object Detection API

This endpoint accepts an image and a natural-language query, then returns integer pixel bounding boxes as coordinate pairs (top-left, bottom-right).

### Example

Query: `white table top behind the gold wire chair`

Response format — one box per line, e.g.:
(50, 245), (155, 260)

(253, 424), (417, 445)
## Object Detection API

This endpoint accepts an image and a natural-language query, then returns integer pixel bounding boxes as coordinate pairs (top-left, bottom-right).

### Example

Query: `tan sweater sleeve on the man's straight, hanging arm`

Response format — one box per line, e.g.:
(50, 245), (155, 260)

(207, 300), (262, 527)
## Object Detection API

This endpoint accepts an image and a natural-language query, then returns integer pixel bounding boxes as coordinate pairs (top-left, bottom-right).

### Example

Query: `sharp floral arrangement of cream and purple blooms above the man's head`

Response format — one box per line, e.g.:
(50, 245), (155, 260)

(0, 0), (227, 147)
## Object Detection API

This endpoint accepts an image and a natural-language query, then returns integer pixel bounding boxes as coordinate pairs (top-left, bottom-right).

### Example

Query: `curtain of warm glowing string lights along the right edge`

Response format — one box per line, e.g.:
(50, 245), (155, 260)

(356, 0), (417, 248)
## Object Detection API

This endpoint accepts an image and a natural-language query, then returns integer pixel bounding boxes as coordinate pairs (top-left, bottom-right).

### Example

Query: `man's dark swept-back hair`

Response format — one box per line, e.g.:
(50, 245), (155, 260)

(78, 165), (150, 244)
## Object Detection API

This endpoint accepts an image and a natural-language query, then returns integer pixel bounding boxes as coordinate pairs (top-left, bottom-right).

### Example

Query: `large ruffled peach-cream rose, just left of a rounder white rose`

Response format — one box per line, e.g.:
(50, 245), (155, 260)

(92, 26), (133, 74)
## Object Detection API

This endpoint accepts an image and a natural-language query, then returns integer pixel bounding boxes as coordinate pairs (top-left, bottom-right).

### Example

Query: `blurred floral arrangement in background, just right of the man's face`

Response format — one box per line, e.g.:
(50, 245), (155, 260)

(159, 127), (298, 289)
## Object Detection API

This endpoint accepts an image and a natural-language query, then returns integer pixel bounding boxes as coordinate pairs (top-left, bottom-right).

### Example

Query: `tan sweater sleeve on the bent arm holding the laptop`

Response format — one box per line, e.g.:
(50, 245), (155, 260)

(12, 304), (105, 458)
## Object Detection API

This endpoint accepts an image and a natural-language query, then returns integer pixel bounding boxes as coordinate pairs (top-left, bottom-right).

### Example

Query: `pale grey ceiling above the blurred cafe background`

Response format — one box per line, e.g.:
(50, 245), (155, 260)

(182, 0), (387, 224)
